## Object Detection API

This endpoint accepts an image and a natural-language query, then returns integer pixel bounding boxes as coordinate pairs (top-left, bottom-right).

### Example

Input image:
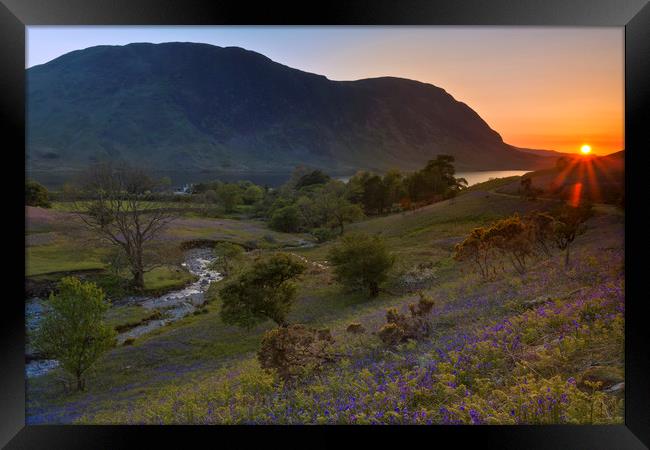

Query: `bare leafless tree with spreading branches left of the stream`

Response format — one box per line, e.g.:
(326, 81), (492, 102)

(73, 163), (176, 290)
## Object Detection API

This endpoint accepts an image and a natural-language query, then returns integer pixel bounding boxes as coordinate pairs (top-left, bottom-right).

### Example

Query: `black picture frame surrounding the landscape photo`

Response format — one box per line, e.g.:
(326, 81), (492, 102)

(0, 0), (650, 449)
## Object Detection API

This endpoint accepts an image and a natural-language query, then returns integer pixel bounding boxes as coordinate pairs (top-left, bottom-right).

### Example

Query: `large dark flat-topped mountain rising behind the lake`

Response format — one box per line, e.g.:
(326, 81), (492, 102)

(27, 42), (555, 172)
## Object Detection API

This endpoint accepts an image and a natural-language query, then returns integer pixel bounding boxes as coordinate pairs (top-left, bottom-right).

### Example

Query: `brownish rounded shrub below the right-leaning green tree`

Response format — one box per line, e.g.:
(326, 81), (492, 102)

(257, 324), (334, 382)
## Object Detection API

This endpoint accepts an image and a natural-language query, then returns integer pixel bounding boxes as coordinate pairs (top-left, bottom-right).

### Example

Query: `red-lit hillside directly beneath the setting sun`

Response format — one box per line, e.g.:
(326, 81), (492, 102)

(497, 150), (625, 203)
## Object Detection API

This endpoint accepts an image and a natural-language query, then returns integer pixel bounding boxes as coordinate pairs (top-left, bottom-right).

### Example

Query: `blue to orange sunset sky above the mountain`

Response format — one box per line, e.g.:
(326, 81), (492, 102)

(26, 26), (625, 154)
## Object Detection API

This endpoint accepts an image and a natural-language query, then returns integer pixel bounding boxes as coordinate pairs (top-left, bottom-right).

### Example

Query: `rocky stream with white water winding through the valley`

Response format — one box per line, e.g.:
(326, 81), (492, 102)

(25, 248), (222, 378)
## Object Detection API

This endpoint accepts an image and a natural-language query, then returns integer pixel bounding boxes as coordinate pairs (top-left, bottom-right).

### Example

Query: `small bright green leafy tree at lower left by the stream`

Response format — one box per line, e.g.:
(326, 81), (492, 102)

(34, 277), (115, 390)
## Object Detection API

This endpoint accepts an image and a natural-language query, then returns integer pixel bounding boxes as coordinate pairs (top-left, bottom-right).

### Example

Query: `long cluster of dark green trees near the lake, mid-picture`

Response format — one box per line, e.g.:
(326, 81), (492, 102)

(258, 155), (467, 241)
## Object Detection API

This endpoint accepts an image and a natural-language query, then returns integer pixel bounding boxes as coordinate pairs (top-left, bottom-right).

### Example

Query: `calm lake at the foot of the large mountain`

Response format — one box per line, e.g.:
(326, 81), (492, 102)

(28, 170), (529, 190)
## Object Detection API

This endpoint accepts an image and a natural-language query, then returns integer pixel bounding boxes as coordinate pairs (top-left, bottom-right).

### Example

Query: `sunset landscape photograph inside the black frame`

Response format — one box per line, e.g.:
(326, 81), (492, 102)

(26, 26), (632, 425)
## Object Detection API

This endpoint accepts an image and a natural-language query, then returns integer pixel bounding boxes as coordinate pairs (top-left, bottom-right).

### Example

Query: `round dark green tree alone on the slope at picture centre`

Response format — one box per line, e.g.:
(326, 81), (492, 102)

(328, 234), (395, 297)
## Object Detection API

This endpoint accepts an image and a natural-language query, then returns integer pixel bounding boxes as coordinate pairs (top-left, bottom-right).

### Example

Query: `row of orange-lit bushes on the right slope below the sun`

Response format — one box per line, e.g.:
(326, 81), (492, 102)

(454, 203), (593, 279)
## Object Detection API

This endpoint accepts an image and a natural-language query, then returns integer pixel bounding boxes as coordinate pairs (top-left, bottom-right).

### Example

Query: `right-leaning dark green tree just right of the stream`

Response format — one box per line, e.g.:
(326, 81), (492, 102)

(219, 253), (305, 328)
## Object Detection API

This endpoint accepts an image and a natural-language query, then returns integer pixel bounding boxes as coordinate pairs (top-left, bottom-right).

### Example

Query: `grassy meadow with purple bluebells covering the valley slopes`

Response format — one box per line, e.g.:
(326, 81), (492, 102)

(26, 191), (624, 424)
